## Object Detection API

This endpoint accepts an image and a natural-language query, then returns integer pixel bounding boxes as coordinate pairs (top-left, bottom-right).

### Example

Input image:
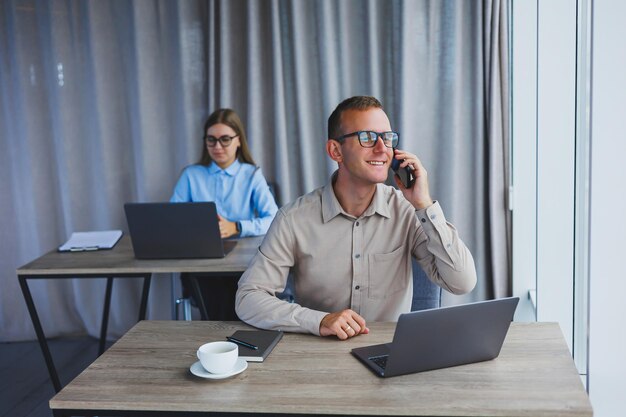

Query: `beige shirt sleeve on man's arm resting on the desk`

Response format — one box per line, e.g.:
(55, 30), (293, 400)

(235, 211), (327, 335)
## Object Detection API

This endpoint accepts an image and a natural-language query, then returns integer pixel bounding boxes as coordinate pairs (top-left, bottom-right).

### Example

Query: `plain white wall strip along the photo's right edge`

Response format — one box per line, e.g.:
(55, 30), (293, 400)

(589, 0), (626, 417)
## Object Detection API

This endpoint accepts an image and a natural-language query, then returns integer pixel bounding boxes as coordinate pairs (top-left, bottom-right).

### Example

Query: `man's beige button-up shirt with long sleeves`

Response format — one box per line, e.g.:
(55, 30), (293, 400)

(236, 176), (476, 334)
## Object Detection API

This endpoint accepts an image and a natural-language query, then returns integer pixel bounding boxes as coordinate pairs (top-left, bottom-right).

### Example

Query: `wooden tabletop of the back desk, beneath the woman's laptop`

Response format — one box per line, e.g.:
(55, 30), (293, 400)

(17, 235), (263, 276)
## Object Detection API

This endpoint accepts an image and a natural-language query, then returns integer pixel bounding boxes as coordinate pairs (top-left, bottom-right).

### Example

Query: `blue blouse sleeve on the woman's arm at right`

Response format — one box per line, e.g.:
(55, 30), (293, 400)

(240, 168), (278, 237)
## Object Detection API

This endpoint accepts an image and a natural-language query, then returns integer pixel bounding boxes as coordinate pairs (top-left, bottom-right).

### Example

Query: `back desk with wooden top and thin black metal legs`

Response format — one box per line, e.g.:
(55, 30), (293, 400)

(17, 235), (263, 392)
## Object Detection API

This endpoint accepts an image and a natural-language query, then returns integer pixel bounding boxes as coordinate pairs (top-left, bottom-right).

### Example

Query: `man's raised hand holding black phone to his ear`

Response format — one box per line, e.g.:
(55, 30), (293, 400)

(391, 149), (433, 210)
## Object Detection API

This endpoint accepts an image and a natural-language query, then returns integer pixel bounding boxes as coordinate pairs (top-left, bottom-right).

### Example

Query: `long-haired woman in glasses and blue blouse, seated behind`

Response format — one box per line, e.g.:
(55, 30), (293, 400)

(170, 109), (278, 320)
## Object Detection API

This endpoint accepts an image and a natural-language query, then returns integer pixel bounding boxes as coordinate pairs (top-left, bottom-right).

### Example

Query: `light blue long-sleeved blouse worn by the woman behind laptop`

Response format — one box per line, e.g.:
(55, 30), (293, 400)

(170, 159), (278, 237)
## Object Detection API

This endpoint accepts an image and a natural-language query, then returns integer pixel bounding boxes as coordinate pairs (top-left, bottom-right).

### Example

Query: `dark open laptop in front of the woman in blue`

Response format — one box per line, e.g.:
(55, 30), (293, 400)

(124, 202), (237, 259)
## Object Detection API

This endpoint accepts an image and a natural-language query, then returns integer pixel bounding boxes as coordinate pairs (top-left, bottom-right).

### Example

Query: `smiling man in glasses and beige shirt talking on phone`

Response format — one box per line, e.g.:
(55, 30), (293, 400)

(236, 96), (476, 340)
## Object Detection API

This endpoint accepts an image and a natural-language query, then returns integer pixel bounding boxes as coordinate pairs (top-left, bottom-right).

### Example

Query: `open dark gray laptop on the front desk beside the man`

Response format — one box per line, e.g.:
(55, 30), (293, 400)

(351, 297), (519, 377)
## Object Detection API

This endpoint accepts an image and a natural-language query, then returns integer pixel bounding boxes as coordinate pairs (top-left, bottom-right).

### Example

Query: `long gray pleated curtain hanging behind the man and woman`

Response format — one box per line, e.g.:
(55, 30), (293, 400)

(0, 0), (510, 341)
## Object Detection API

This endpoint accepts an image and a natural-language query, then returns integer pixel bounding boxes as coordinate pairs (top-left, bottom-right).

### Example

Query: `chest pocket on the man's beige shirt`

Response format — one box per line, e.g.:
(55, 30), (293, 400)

(368, 246), (411, 299)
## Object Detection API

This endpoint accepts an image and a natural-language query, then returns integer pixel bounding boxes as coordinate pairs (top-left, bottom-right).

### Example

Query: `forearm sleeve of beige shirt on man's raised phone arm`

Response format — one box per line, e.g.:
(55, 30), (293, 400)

(413, 201), (476, 294)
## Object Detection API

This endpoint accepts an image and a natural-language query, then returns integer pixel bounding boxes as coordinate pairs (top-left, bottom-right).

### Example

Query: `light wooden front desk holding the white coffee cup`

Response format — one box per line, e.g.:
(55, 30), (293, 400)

(50, 321), (592, 417)
